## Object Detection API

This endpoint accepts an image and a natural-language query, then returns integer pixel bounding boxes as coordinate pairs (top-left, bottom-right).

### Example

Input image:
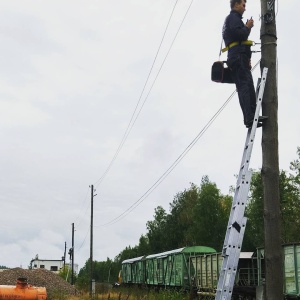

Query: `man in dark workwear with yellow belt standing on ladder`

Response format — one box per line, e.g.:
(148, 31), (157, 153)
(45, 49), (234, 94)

(222, 0), (268, 128)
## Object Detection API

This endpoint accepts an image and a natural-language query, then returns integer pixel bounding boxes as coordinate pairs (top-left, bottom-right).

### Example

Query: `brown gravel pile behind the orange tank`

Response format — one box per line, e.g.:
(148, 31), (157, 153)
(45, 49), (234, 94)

(0, 268), (76, 295)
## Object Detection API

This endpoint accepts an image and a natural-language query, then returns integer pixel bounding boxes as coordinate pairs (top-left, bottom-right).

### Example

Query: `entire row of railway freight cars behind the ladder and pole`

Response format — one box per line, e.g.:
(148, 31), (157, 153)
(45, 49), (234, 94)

(120, 243), (300, 300)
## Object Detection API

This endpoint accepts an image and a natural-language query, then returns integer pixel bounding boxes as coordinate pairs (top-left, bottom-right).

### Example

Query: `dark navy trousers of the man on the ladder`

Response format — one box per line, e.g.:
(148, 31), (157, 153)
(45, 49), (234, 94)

(228, 53), (256, 125)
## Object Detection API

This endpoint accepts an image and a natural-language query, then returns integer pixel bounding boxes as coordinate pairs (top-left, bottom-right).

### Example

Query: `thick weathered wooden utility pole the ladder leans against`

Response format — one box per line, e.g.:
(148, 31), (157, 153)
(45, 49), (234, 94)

(261, 0), (283, 300)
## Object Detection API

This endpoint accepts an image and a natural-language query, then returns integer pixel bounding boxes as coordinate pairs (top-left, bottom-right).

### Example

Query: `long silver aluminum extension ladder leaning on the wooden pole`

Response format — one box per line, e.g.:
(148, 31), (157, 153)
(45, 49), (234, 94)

(215, 68), (268, 300)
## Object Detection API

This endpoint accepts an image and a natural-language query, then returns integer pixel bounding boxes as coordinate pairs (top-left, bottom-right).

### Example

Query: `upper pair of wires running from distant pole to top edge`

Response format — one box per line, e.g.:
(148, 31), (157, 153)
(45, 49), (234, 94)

(94, 0), (194, 187)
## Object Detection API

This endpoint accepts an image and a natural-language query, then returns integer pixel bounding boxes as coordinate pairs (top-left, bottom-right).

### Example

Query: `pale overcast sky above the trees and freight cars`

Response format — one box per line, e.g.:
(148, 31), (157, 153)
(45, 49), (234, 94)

(0, 0), (300, 268)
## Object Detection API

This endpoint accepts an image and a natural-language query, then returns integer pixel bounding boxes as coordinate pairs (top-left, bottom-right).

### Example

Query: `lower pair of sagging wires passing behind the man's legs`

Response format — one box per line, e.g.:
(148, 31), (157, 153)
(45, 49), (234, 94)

(95, 60), (260, 227)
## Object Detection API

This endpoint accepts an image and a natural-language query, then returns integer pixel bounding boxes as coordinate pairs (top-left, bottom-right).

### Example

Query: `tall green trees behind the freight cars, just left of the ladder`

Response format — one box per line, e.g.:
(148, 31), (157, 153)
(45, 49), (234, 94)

(142, 176), (232, 254)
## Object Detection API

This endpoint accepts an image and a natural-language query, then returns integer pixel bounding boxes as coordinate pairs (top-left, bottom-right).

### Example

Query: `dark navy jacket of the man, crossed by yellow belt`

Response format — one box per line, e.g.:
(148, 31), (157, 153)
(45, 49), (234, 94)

(223, 10), (251, 59)
